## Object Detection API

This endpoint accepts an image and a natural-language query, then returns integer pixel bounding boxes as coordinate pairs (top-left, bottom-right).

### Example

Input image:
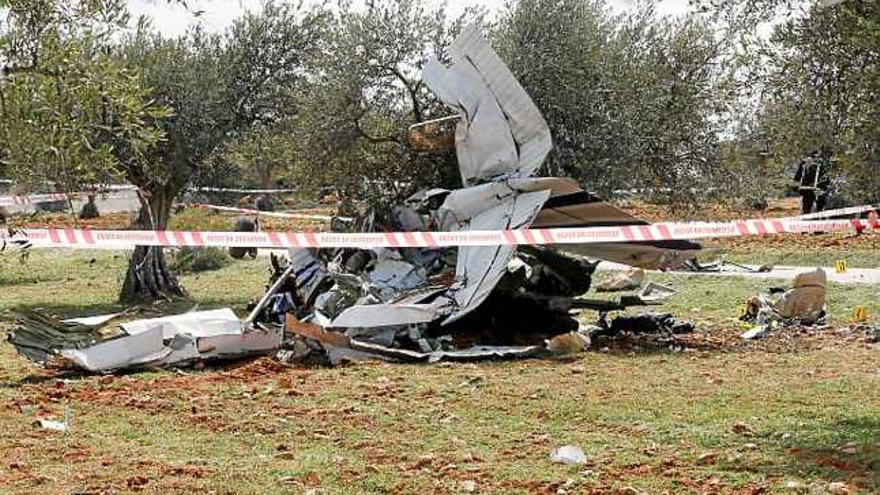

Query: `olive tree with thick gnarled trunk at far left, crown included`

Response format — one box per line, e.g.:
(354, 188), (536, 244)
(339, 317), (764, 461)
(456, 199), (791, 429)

(0, 0), (330, 302)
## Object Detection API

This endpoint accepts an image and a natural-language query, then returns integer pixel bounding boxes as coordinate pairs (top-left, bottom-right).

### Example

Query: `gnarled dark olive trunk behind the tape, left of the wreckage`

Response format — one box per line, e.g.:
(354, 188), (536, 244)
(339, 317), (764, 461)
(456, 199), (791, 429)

(119, 188), (186, 303)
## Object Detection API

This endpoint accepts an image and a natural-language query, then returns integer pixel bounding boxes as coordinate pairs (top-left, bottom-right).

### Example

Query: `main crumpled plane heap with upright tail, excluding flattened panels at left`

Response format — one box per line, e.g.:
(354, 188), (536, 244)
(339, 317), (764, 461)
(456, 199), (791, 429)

(256, 26), (700, 362)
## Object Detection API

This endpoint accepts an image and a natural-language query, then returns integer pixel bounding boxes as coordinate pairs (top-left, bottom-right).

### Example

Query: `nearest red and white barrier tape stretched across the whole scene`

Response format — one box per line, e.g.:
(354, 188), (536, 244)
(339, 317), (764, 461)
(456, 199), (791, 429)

(0, 215), (880, 249)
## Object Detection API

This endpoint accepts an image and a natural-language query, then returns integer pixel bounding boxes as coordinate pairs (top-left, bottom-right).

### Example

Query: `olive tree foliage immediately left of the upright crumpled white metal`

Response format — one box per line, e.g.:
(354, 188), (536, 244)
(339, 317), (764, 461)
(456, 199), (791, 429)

(272, 0), (482, 209)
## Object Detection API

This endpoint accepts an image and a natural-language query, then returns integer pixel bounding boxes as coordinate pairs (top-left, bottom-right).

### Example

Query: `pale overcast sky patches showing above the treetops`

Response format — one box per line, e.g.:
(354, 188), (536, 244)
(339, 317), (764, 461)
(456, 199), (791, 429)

(129, 0), (688, 36)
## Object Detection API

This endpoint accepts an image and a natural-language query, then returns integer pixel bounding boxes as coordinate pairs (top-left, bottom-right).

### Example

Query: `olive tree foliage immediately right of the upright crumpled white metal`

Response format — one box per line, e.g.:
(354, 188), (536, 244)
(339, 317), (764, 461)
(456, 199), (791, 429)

(495, 0), (729, 203)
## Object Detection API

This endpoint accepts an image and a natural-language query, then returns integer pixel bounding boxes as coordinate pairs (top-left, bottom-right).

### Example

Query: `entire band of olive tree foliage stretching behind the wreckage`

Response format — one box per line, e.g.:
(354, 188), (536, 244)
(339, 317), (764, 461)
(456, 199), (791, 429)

(0, 0), (880, 211)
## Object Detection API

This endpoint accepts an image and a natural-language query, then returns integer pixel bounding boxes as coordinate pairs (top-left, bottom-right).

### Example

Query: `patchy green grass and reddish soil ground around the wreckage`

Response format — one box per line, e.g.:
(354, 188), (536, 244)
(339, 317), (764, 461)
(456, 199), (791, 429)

(0, 251), (880, 494)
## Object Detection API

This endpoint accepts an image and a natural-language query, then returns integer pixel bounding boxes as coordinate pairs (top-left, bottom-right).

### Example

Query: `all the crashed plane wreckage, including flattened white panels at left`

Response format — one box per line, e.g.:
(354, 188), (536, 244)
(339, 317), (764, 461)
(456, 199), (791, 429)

(1, 26), (700, 371)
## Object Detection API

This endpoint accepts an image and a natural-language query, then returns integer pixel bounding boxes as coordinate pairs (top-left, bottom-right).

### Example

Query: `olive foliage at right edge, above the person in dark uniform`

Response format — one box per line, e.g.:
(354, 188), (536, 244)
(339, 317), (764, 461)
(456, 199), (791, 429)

(759, 1), (880, 200)
